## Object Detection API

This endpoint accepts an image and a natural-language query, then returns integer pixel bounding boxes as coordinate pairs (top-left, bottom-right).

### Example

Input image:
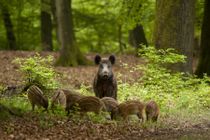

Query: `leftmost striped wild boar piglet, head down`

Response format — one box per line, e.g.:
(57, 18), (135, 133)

(27, 85), (48, 111)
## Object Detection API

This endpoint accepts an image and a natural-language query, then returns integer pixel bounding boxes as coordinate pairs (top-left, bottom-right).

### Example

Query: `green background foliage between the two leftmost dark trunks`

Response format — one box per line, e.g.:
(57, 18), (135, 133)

(10, 0), (41, 50)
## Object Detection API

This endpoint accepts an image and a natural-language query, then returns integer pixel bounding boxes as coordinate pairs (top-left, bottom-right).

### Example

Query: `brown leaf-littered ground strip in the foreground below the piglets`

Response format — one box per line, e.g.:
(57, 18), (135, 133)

(0, 113), (210, 140)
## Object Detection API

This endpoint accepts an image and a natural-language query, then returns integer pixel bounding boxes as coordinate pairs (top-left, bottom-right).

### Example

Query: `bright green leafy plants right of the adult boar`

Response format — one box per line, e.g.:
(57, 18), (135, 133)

(118, 47), (210, 114)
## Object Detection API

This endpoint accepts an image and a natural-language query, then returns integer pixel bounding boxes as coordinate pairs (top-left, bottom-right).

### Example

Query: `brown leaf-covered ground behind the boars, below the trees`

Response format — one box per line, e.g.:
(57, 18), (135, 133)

(0, 51), (143, 88)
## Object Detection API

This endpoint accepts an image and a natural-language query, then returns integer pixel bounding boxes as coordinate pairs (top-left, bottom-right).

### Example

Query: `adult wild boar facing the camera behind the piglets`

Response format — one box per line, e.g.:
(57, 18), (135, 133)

(93, 55), (117, 100)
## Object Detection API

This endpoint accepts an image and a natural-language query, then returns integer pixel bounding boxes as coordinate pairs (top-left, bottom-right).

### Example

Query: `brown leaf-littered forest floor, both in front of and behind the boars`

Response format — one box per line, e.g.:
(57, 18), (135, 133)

(0, 51), (210, 140)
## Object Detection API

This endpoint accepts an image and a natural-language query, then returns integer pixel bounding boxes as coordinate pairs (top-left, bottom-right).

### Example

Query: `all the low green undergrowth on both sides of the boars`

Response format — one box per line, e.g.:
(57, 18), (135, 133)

(1, 47), (210, 127)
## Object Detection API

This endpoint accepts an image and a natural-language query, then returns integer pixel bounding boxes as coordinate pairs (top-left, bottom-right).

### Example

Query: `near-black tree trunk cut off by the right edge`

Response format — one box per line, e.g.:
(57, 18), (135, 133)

(195, 0), (210, 77)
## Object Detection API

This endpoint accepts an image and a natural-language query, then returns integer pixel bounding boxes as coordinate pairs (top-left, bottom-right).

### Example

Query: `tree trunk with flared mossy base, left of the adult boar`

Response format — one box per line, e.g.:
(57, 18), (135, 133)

(56, 0), (87, 66)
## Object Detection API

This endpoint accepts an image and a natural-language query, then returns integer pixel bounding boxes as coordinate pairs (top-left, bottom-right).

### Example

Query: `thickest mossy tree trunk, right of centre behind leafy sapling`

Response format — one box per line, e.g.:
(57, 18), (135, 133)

(154, 0), (195, 73)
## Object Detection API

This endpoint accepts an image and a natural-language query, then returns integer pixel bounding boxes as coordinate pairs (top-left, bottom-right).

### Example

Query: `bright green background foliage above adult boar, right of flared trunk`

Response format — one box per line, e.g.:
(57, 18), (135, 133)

(72, 0), (122, 53)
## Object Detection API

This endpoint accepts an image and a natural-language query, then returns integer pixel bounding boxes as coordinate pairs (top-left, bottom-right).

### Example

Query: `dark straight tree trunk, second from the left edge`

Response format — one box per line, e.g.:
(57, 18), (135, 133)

(41, 0), (53, 51)
